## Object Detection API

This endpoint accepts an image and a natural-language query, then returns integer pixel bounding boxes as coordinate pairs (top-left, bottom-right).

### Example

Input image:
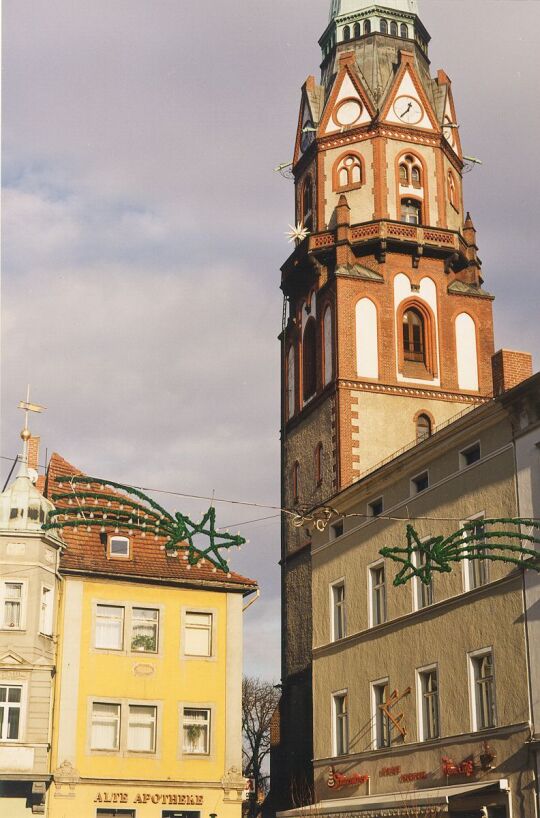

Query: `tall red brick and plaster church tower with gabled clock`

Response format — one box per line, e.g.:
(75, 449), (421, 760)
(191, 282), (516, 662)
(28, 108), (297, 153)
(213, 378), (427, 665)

(272, 0), (494, 808)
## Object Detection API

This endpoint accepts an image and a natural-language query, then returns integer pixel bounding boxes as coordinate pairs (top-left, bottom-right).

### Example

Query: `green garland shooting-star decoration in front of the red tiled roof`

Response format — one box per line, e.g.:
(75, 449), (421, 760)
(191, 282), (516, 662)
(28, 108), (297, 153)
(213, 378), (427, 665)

(43, 475), (246, 576)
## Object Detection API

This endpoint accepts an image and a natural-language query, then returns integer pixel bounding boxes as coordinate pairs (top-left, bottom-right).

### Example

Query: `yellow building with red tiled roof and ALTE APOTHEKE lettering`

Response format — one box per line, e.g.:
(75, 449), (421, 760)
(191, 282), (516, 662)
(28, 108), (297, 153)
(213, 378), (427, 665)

(47, 452), (256, 818)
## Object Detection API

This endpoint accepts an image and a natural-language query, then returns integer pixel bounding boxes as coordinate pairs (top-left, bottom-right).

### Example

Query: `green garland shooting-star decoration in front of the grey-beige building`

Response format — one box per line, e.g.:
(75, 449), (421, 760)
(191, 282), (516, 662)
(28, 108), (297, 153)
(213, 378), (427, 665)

(379, 517), (540, 586)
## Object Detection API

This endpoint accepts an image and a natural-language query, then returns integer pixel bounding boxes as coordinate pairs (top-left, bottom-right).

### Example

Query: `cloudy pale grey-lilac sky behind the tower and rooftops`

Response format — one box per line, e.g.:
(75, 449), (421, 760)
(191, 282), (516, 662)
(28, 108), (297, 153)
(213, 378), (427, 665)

(0, 0), (540, 681)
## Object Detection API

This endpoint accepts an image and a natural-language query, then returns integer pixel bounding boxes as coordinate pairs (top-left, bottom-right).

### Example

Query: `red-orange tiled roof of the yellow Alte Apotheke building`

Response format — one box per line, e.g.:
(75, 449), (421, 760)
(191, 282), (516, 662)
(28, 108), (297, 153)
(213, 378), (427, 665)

(44, 453), (257, 591)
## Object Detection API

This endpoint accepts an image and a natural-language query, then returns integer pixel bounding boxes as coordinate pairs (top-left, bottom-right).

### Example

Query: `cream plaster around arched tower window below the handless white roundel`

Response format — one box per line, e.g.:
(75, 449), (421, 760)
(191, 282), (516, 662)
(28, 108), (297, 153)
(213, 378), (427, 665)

(324, 140), (374, 225)
